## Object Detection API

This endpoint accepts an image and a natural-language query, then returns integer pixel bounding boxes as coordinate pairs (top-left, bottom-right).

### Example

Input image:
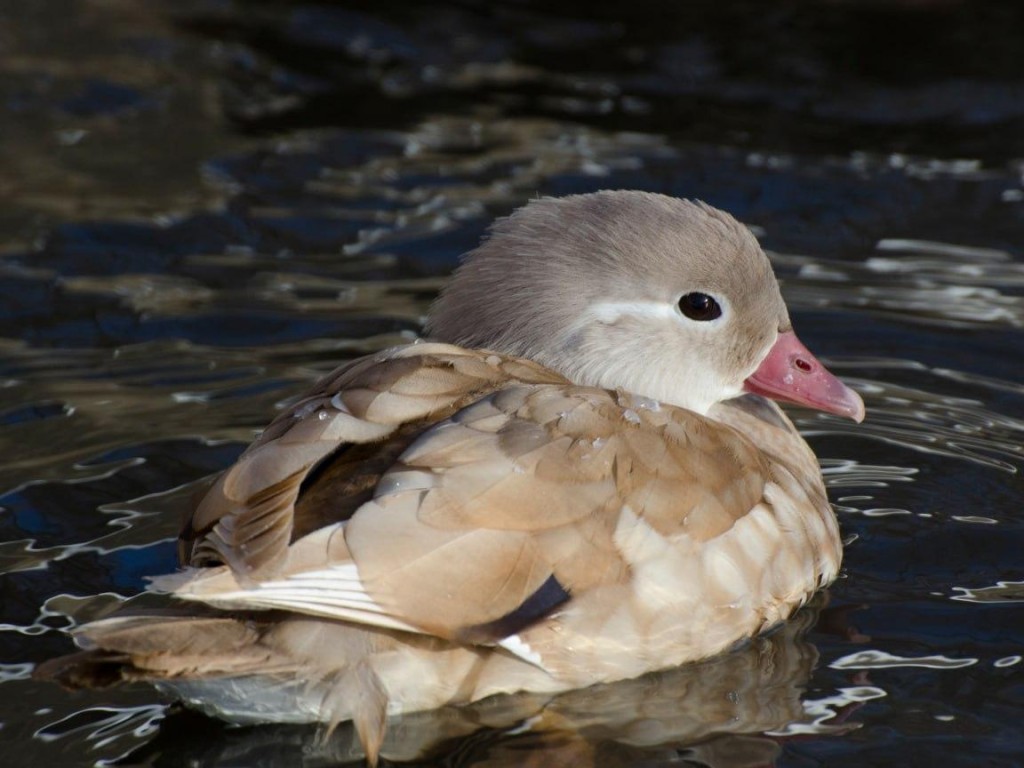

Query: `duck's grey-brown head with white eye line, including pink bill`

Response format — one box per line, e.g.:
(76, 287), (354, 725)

(428, 191), (864, 421)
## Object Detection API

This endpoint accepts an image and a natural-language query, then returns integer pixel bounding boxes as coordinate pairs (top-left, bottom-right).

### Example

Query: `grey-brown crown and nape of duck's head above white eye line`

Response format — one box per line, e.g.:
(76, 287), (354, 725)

(427, 190), (787, 365)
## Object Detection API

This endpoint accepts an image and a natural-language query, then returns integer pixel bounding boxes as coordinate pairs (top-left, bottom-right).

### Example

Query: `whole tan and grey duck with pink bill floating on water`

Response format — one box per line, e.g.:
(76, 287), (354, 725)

(37, 190), (864, 764)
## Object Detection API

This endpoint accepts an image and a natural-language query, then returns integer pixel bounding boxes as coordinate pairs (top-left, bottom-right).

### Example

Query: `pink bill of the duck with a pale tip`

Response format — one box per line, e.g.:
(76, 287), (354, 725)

(743, 331), (864, 422)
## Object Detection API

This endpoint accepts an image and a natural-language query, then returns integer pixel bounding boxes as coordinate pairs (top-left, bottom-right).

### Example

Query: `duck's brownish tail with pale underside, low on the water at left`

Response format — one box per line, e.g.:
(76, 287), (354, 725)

(34, 606), (388, 765)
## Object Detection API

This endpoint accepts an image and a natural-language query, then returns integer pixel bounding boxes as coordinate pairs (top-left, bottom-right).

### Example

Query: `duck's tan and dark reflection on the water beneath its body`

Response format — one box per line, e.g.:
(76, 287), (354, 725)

(119, 599), (823, 768)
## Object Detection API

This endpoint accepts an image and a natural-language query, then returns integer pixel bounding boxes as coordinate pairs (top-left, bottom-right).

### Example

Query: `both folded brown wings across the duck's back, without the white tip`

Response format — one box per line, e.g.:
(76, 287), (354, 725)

(174, 345), (770, 642)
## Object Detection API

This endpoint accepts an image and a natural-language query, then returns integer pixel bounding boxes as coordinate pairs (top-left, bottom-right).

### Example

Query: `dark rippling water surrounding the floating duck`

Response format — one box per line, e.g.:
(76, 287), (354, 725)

(0, 0), (1024, 768)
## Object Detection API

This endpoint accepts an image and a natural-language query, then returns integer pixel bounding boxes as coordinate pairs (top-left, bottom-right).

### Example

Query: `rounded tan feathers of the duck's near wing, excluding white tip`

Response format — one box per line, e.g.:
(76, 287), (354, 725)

(345, 384), (768, 639)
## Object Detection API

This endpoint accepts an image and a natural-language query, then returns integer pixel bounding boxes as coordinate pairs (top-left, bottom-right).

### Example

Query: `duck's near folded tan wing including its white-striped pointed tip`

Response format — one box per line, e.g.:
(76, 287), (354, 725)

(167, 357), (770, 643)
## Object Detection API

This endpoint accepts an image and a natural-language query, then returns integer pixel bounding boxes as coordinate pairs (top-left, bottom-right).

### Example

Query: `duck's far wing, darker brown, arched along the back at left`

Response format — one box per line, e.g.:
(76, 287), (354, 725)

(179, 344), (564, 580)
